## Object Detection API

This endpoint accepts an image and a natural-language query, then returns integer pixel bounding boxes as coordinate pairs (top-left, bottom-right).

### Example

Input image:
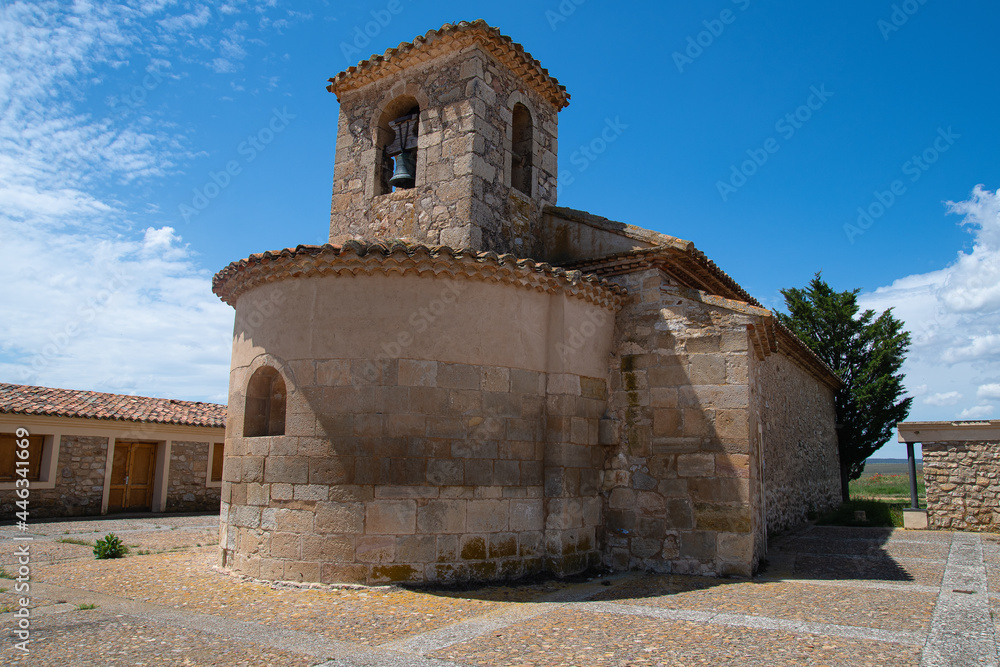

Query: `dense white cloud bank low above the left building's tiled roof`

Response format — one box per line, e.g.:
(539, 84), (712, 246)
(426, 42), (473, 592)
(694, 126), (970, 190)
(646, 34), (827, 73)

(0, 223), (232, 401)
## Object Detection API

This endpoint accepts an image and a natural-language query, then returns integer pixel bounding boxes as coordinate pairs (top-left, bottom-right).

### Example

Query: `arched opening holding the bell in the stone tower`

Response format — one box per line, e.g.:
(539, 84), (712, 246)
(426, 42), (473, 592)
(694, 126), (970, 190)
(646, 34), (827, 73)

(375, 97), (420, 195)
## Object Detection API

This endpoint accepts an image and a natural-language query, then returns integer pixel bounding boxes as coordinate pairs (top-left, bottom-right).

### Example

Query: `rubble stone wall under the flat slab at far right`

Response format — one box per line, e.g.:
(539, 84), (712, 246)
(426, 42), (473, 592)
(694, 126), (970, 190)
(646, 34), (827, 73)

(921, 441), (1000, 532)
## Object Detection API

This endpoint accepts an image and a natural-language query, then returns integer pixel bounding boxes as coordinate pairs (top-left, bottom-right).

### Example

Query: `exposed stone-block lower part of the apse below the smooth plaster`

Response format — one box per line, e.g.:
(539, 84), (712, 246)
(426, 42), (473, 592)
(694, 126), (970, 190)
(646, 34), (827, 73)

(222, 359), (606, 583)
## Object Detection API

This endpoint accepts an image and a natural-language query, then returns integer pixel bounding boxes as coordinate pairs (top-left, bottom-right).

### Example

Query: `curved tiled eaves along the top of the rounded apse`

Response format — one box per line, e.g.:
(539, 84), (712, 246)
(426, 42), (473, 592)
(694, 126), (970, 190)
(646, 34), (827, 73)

(212, 240), (626, 309)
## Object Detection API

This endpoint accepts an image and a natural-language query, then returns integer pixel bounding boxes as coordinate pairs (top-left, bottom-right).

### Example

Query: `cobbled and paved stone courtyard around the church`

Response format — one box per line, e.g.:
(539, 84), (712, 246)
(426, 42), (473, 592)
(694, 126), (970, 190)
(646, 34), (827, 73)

(0, 516), (1000, 667)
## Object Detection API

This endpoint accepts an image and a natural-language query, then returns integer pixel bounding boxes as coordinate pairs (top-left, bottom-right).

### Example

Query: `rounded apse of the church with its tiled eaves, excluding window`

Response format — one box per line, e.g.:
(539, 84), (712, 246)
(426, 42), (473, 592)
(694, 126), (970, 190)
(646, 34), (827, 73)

(216, 242), (621, 583)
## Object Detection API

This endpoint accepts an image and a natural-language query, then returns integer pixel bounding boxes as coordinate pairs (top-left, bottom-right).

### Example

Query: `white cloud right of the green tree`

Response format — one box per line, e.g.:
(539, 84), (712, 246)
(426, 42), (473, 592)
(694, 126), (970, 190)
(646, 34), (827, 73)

(859, 186), (1000, 428)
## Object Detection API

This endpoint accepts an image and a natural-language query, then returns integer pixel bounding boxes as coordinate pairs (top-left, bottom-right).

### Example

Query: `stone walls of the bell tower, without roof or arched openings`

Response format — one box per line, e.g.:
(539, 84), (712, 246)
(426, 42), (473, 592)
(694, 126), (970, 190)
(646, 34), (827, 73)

(330, 46), (558, 257)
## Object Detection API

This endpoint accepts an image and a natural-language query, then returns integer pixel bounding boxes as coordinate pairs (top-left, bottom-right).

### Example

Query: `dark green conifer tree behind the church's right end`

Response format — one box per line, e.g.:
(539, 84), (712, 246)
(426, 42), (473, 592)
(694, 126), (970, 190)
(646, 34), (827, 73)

(777, 273), (913, 501)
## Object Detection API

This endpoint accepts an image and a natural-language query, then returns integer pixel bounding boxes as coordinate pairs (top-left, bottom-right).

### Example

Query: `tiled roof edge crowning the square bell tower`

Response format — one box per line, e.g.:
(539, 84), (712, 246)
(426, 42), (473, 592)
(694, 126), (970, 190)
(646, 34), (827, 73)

(327, 19), (569, 110)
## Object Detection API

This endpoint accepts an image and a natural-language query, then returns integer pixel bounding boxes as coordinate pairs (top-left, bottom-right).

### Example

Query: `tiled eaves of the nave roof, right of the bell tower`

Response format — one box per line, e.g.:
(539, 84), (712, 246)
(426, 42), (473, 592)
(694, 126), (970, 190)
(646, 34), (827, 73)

(569, 245), (843, 389)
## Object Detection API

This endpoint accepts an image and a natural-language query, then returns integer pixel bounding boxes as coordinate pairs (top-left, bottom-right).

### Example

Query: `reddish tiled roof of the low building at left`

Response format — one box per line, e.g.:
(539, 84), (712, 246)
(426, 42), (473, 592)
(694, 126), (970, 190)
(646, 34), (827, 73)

(0, 382), (226, 427)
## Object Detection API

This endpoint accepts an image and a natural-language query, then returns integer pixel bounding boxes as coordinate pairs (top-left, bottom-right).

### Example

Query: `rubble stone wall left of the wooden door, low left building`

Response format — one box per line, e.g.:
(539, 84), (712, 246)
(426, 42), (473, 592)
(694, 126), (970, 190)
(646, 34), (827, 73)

(0, 435), (108, 519)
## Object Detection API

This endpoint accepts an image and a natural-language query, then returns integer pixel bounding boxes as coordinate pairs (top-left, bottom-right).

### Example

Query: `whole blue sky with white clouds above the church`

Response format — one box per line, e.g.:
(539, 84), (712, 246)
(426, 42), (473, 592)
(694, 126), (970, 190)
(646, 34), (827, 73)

(0, 0), (1000, 456)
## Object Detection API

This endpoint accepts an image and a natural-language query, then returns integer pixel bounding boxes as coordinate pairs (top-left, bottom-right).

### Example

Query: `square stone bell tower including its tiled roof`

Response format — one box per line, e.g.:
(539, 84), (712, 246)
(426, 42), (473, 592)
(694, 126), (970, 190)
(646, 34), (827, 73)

(327, 20), (569, 257)
